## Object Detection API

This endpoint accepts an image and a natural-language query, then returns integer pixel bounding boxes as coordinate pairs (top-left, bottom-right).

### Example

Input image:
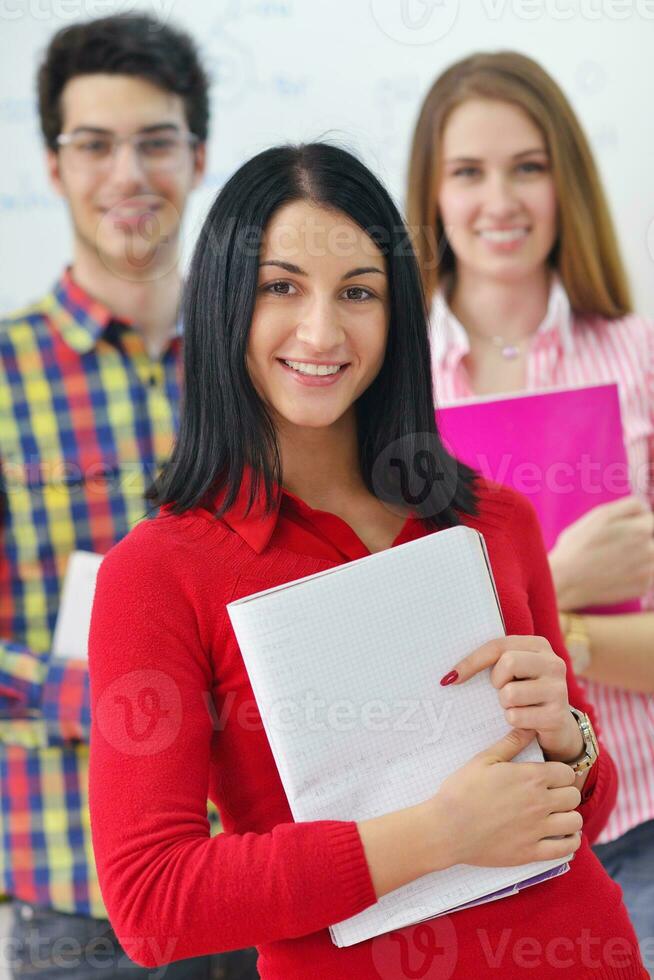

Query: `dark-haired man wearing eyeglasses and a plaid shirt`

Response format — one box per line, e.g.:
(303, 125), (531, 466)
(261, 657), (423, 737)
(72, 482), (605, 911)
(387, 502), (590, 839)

(0, 15), (258, 980)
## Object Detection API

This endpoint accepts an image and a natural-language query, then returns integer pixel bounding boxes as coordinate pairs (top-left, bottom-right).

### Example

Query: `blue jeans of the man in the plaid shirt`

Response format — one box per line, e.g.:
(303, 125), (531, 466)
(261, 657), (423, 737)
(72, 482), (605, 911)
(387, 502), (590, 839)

(2, 900), (259, 980)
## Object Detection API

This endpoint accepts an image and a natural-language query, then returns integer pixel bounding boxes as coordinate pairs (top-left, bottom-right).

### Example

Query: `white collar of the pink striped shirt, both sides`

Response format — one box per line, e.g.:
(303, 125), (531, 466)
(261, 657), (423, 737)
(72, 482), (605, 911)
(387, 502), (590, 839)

(430, 275), (574, 364)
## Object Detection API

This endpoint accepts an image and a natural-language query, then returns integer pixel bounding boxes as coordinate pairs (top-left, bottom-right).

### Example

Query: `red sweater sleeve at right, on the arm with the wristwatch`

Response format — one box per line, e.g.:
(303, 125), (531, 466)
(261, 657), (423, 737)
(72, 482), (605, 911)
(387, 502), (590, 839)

(514, 494), (618, 843)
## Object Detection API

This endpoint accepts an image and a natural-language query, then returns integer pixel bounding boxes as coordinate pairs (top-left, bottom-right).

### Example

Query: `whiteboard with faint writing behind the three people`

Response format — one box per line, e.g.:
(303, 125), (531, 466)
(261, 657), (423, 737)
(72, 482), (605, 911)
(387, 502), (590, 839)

(0, 0), (654, 315)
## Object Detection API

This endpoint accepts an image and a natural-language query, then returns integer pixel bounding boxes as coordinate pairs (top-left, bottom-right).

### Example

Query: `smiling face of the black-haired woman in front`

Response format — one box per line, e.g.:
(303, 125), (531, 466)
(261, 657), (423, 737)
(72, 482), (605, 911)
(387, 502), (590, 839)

(247, 200), (389, 428)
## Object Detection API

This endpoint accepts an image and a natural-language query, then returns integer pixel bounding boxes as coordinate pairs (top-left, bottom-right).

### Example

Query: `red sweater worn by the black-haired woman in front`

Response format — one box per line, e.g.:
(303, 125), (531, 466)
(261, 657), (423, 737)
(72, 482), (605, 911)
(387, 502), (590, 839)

(90, 484), (646, 980)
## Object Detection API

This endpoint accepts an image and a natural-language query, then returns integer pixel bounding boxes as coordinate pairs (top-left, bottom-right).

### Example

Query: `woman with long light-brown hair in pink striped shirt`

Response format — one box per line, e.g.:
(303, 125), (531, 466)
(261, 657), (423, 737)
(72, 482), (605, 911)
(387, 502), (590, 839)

(408, 52), (654, 970)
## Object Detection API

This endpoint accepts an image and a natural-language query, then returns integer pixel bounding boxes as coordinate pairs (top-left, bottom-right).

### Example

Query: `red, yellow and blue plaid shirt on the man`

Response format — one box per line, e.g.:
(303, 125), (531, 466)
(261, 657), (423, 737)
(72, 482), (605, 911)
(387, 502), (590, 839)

(0, 272), (181, 918)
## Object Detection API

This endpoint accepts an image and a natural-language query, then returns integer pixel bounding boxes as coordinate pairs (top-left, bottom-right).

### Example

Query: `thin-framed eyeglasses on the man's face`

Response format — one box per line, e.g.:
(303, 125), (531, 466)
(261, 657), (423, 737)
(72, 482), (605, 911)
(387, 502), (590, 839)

(56, 130), (199, 173)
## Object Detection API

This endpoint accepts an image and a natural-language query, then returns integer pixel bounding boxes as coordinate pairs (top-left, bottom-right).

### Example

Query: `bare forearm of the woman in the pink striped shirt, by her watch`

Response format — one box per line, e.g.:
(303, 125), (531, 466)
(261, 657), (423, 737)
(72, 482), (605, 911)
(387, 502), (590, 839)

(579, 612), (654, 694)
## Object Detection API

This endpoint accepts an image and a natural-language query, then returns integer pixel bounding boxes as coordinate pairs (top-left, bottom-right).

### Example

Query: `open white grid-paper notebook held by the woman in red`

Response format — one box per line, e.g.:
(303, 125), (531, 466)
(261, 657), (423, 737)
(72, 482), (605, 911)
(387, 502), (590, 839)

(227, 527), (568, 946)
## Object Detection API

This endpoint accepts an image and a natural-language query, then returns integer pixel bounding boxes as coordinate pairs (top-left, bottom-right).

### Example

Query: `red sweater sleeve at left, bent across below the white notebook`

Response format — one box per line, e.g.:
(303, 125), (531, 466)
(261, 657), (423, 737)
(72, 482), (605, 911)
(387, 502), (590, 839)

(89, 521), (376, 967)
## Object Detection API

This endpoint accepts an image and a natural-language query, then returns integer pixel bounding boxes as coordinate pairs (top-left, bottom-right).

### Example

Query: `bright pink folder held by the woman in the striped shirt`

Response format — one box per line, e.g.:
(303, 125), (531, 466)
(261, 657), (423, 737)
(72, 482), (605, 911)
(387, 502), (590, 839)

(436, 384), (641, 613)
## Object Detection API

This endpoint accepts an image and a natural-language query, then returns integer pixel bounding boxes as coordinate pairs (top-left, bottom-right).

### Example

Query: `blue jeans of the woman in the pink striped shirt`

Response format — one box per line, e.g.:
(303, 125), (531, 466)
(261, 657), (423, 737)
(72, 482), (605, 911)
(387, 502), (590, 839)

(594, 820), (654, 977)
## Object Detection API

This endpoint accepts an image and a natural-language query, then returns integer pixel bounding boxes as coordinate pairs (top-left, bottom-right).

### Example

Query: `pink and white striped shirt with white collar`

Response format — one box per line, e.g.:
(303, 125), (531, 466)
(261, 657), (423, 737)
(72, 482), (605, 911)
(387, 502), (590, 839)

(431, 279), (654, 843)
